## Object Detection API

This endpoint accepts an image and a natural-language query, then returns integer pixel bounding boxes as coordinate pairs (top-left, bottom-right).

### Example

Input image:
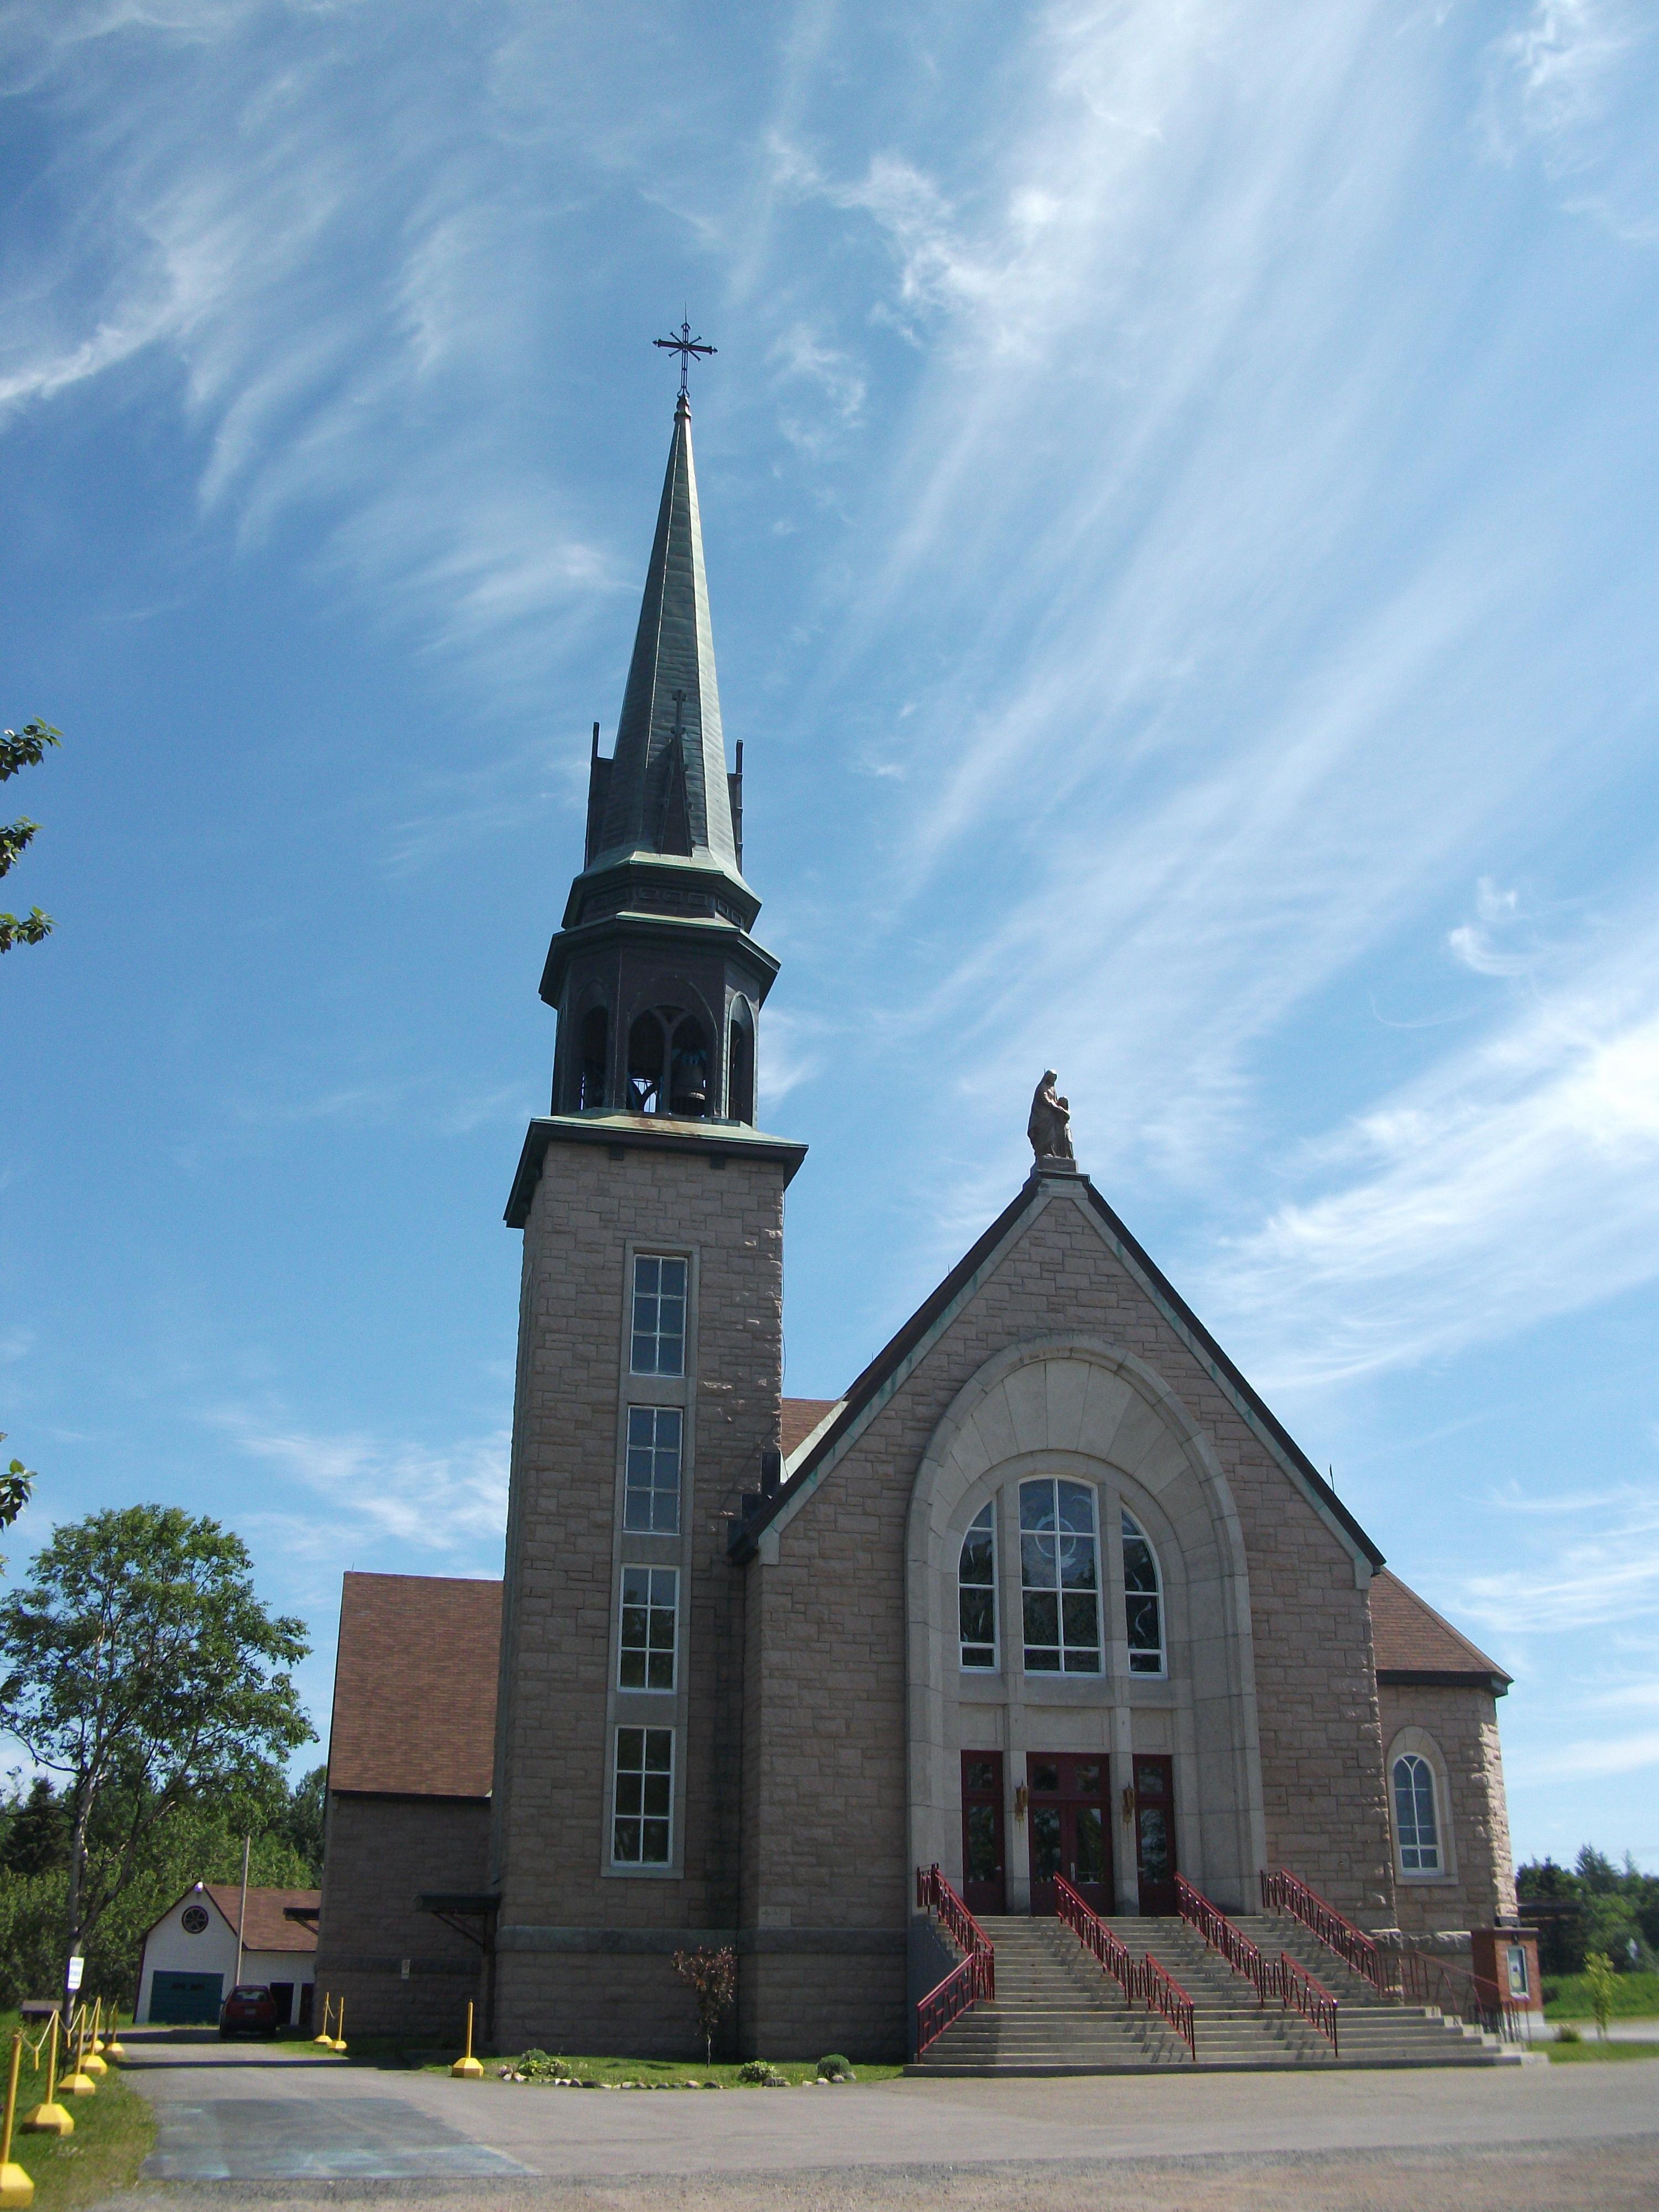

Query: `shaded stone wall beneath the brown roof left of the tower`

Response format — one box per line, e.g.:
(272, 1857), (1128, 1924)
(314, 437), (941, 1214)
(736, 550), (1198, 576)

(316, 1792), (489, 2048)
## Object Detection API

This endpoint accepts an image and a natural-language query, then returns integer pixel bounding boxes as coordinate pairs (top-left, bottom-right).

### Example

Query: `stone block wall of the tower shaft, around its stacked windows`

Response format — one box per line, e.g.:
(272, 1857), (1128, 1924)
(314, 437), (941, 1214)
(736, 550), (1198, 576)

(493, 1137), (787, 2051)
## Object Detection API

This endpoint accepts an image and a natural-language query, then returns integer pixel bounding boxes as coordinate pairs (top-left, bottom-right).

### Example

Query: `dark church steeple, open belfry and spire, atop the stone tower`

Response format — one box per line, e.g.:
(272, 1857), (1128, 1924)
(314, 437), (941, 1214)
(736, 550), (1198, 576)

(542, 387), (776, 1124)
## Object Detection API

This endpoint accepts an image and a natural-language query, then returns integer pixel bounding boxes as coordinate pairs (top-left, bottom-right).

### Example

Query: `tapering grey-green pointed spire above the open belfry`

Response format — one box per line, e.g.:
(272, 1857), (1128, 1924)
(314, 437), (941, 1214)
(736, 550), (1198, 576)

(588, 392), (739, 874)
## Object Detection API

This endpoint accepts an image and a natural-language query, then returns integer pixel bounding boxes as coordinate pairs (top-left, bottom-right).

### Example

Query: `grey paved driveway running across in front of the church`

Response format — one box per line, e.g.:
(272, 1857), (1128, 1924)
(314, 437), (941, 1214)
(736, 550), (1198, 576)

(104, 2031), (1659, 2212)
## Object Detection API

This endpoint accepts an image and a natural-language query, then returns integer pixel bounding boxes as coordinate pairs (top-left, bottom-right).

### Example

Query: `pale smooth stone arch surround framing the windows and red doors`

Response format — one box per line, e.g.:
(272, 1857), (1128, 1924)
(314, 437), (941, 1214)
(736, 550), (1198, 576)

(905, 1336), (1265, 1911)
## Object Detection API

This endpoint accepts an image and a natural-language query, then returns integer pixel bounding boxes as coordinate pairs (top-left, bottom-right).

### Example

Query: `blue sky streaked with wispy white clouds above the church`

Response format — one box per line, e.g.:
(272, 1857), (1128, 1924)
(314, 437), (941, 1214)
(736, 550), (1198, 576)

(0, 0), (1659, 1867)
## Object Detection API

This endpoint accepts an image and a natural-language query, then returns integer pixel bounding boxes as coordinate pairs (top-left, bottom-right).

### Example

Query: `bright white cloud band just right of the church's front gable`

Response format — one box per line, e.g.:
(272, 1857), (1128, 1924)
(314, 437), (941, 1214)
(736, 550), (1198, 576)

(1210, 916), (1659, 1387)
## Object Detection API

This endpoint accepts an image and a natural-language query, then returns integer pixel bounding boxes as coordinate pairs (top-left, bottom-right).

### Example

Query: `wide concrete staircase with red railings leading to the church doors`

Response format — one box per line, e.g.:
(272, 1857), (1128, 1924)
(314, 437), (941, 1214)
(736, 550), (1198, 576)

(909, 1916), (1520, 2075)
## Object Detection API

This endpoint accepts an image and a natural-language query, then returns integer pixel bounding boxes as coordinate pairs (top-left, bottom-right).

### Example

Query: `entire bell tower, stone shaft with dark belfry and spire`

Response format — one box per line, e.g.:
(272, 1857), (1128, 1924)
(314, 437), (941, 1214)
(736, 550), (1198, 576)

(487, 367), (805, 2053)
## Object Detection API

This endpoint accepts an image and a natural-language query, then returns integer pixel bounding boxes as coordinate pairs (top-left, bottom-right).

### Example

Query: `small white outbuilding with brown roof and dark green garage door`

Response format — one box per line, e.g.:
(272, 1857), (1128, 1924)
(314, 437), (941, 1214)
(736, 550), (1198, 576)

(133, 1882), (321, 2026)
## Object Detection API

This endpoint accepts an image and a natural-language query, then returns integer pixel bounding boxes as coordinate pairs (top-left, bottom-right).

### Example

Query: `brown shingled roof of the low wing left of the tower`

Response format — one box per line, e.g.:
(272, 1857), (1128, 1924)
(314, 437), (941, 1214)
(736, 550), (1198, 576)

(327, 1575), (502, 1798)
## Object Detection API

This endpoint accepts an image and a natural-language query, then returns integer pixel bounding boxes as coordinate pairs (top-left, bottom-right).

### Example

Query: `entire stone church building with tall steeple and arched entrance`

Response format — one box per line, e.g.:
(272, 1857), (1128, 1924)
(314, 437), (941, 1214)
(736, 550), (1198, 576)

(316, 376), (1515, 2059)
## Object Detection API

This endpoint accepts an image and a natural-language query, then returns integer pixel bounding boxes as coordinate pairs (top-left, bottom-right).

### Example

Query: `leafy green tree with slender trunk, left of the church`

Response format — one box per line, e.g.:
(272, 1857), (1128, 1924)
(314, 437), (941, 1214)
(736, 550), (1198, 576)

(0, 1506), (312, 2008)
